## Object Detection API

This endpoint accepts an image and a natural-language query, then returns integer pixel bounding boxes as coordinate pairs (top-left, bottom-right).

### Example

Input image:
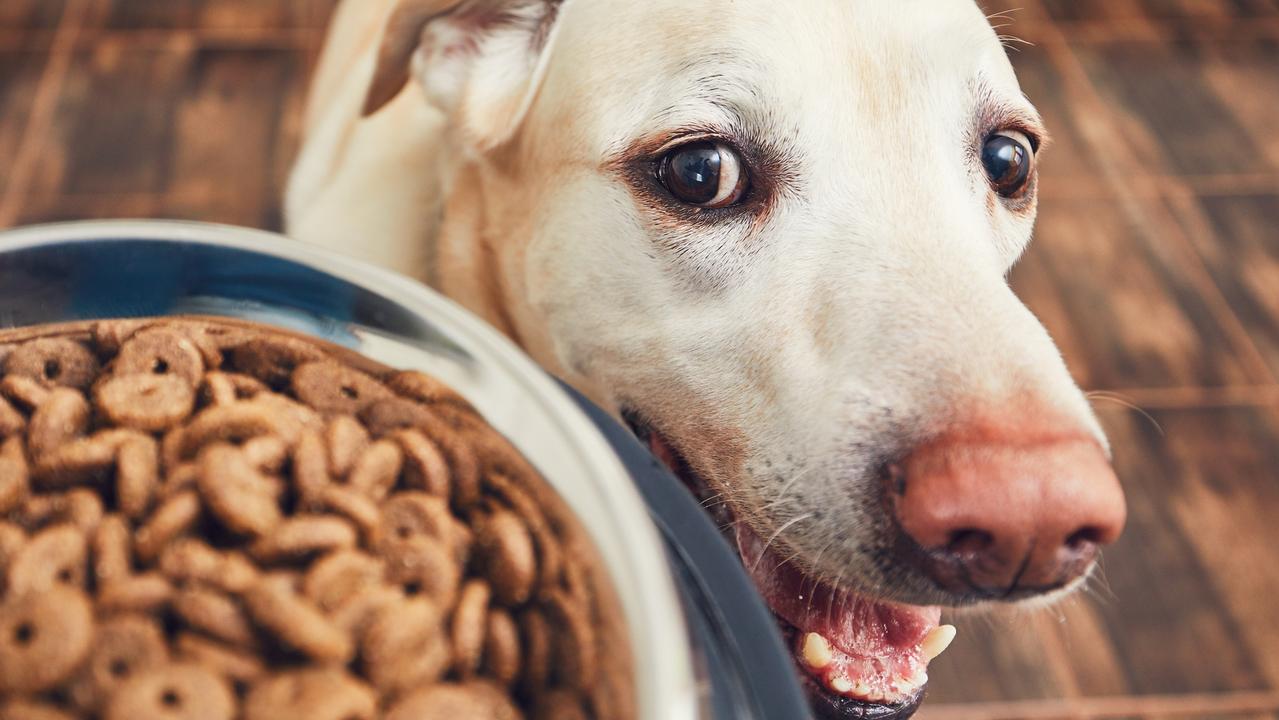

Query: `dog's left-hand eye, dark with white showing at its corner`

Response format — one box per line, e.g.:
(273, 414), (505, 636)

(657, 141), (747, 207)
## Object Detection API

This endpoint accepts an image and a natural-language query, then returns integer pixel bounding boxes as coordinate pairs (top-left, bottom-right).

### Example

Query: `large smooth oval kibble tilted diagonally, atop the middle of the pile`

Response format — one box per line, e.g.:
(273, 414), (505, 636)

(196, 444), (281, 536)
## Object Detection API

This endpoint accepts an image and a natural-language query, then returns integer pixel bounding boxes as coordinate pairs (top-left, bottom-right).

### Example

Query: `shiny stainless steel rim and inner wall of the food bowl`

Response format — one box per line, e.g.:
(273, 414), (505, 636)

(0, 220), (702, 720)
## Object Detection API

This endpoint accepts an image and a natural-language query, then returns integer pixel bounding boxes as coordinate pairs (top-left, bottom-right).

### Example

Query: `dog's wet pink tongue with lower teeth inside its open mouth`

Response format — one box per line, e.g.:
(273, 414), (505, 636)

(737, 522), (954, 703)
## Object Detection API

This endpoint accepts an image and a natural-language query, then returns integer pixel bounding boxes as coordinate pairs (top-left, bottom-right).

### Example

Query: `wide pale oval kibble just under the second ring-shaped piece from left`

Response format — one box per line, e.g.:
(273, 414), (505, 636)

(93, 375), (196, 432)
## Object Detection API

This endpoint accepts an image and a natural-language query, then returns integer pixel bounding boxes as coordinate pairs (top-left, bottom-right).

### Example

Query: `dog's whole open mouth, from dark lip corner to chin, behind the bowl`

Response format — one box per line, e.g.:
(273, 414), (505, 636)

(627, 413), (955, 720)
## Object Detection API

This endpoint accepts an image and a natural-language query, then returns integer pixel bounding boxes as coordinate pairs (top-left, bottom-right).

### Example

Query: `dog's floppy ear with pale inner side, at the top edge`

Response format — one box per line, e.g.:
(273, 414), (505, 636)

(365, 0), (561, 150)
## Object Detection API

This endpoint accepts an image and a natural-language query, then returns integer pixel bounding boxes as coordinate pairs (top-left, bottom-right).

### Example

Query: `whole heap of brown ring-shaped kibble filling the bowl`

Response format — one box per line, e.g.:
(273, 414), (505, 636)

(0, 318), (634, 720)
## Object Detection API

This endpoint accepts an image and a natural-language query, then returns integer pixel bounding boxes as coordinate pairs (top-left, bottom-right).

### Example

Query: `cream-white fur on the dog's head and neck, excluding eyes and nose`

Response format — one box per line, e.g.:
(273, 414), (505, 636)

(288, 0), (1104, 601)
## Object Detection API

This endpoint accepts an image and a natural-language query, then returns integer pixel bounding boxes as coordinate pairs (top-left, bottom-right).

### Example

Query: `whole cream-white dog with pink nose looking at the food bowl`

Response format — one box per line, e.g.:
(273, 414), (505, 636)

(286, 0), (1126, 719)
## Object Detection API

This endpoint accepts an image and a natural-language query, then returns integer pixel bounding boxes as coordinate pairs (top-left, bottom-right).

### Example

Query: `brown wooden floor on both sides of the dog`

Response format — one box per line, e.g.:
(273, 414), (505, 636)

(0, 0), (1279, 720)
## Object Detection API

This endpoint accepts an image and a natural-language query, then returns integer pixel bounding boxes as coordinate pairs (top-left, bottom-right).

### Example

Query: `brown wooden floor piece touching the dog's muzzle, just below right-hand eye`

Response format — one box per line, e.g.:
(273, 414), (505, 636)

(1012, 197), (1270, 390)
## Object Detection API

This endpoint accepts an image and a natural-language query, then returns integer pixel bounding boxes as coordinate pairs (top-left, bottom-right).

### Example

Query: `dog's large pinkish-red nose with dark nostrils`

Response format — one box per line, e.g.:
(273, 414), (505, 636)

(890, 436), (1126, 599)
